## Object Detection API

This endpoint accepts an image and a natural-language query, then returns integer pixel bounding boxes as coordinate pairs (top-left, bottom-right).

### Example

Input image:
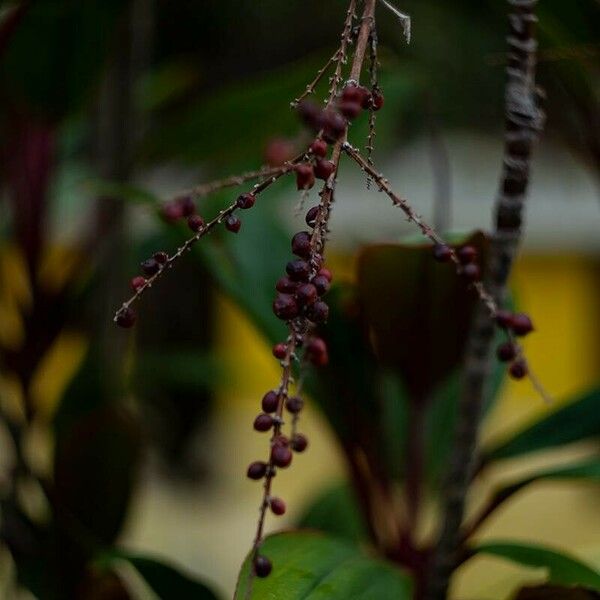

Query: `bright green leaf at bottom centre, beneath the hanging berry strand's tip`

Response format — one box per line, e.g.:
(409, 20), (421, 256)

(235, 532), (412, 600)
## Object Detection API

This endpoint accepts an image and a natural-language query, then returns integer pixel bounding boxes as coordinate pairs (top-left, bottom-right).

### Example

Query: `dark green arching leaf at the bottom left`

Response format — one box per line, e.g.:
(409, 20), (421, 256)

(97, 550), (218, 600)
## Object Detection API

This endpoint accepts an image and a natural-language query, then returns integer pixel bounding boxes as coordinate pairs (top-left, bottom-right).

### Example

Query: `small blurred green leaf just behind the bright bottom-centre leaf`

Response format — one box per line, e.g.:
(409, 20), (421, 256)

(298, 483), (367, 543)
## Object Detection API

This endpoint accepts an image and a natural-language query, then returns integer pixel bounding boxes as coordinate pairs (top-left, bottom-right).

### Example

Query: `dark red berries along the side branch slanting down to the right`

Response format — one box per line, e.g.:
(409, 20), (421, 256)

(433, 244), (533, 379)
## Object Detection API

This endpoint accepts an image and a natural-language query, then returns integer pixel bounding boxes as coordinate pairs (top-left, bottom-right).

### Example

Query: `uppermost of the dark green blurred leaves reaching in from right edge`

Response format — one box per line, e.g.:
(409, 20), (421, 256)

(482, 389), (600, 463)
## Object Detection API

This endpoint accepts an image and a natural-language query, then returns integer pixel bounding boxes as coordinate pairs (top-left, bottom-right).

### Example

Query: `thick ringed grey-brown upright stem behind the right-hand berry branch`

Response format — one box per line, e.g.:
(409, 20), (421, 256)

(426, 0), (543, 600)
